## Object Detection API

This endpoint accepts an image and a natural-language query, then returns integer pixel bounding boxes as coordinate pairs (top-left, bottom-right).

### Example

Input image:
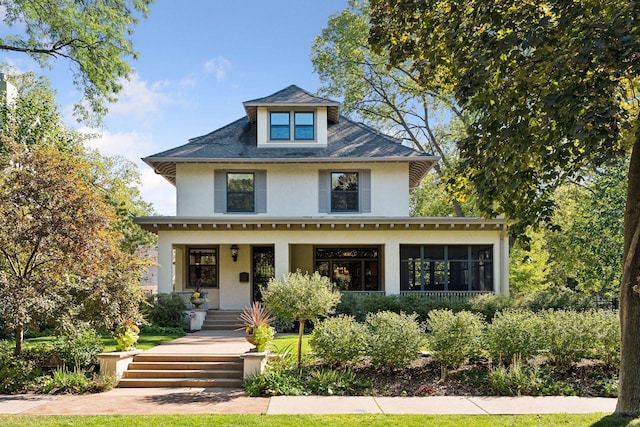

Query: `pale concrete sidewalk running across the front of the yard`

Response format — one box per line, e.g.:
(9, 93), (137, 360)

(0, 388), (616, 415)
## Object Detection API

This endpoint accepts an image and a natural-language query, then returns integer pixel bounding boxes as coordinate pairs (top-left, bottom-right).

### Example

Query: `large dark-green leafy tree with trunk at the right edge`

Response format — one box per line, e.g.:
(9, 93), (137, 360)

(369, 0), (640, 415)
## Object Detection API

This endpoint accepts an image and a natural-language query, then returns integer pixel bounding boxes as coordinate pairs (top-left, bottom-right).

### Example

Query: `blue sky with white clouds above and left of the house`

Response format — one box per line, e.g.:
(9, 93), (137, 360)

(0, 0), (347, 215)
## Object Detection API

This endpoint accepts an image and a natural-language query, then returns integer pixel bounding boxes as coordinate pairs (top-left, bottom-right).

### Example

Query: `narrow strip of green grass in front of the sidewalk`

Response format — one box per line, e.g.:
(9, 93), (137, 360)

(0, 414), (640, 427)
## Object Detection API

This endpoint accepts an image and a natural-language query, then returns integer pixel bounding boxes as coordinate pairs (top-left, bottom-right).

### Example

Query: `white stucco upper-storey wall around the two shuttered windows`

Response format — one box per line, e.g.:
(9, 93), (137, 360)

(176, 163), (409, 217)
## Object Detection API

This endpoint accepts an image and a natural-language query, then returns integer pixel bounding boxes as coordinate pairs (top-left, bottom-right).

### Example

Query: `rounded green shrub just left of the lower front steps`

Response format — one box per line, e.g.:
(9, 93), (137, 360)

(54, 329), (104, 369)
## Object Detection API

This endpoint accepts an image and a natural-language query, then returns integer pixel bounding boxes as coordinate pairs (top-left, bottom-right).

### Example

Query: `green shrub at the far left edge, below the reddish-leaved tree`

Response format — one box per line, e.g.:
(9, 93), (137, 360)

(0, 341), (41, 394)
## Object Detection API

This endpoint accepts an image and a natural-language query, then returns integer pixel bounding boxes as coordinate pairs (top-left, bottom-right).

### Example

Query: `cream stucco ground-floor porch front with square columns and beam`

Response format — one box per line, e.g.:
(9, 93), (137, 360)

(158, 226), (508, 309)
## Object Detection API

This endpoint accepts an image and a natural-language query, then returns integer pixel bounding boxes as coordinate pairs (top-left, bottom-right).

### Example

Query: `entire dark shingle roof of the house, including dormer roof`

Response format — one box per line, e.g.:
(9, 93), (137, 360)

(143, 85), (438, 188)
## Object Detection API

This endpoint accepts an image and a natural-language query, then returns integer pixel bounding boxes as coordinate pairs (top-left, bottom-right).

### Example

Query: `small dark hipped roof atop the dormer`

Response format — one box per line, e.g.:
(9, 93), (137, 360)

(242, 85), (340, 123)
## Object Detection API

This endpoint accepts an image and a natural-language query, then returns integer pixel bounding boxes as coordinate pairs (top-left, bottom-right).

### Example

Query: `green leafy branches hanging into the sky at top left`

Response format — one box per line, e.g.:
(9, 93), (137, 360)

(0, 0), (152, 123)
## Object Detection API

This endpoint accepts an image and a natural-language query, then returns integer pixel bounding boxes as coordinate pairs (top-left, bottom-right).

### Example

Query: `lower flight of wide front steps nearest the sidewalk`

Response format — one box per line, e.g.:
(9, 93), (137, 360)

(118, 353), (244, 387)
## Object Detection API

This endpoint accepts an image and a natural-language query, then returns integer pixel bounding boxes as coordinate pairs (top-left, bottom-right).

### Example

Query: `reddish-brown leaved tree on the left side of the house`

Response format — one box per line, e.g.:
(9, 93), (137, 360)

(0, 140), (142, 354)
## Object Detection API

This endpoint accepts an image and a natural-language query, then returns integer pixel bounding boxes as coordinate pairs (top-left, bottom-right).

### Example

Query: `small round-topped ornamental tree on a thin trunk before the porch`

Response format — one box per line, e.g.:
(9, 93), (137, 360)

(261, 270), (340, 368)
